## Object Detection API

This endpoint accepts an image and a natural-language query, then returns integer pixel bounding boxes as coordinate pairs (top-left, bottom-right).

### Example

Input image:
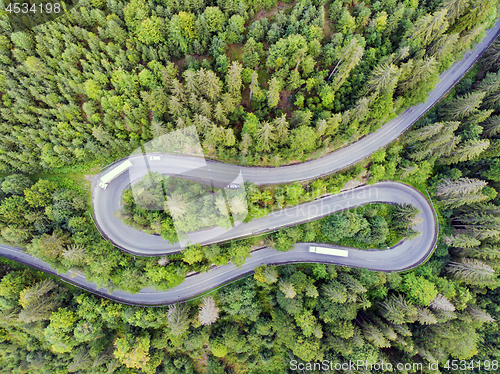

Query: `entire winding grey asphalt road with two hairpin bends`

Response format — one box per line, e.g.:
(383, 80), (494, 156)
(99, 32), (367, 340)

(0, 20), (500, 305)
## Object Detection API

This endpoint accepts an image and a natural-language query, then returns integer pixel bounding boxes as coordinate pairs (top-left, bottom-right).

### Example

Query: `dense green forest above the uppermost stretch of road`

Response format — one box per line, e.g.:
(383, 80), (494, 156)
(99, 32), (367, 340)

(0, 0), (498, 173)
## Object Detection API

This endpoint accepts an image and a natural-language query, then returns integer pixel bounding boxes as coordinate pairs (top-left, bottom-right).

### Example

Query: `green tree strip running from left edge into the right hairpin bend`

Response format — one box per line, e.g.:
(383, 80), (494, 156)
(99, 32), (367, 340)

(0, 169), (417, 292)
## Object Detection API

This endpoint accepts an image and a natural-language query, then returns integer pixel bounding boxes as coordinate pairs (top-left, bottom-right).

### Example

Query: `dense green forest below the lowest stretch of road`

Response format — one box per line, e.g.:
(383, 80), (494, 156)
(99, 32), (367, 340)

(0, 234), (500, 374)
